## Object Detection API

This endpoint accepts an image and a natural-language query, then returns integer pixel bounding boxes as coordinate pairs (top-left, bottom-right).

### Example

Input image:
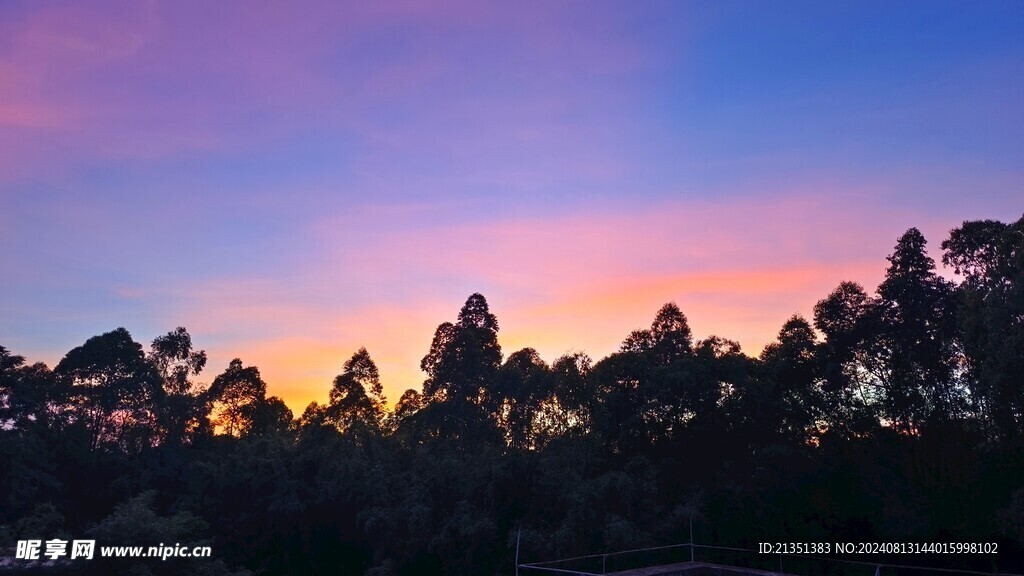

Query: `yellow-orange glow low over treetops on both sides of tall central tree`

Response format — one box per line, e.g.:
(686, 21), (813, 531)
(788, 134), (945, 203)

(191, 260), (883, 415)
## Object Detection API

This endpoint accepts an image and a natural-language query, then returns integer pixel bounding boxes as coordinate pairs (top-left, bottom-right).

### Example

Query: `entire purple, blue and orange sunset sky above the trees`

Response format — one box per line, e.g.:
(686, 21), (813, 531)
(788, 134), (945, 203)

(0, 0), (1024, 413)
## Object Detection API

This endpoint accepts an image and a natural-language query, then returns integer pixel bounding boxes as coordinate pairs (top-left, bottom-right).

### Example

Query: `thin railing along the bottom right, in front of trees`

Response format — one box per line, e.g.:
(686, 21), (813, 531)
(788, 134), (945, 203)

(516, 543), (1024, 576)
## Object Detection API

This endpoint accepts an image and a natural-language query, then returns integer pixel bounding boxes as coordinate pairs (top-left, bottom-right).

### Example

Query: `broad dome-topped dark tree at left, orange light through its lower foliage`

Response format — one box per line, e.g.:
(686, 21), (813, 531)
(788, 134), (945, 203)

(54, 328), (162, 451)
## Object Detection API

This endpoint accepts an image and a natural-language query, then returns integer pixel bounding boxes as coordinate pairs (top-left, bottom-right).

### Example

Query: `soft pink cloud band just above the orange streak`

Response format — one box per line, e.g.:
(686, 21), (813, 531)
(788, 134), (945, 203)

(310, 180), (921, 298)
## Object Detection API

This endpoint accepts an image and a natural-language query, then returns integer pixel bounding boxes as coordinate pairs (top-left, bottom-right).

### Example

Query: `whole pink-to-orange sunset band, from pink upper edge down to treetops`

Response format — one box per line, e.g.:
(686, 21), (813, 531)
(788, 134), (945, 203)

(146, 186), (938, 411)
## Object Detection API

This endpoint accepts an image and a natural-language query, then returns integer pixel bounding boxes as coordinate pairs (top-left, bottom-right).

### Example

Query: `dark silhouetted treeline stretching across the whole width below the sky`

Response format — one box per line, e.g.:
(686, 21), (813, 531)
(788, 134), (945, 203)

(0, 217), (1024, 576)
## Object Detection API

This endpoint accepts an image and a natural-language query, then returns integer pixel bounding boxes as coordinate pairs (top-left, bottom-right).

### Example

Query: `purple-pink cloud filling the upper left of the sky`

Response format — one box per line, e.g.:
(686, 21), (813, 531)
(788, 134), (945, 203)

(0, 0), (655, 181)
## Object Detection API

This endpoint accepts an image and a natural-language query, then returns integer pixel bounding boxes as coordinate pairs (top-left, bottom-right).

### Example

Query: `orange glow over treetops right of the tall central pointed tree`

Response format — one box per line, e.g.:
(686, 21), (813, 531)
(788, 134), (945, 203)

(499, 264), (882, 361)
